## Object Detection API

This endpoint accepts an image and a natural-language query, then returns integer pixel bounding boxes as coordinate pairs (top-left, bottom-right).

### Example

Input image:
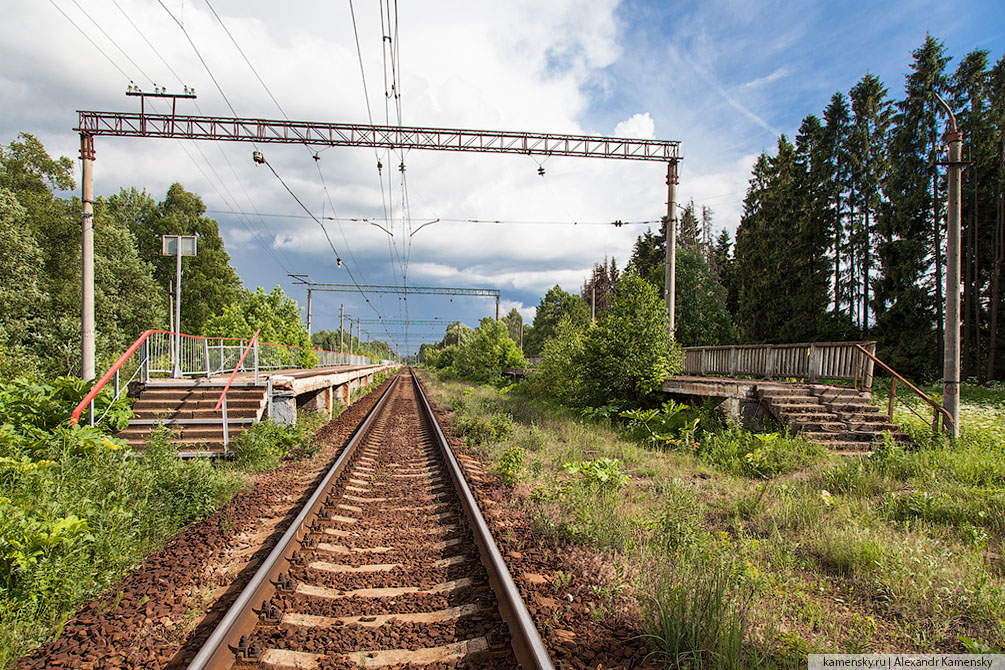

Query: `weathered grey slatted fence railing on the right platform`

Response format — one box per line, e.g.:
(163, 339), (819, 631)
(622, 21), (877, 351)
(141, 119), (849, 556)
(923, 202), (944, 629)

(681, 342), (876, 389)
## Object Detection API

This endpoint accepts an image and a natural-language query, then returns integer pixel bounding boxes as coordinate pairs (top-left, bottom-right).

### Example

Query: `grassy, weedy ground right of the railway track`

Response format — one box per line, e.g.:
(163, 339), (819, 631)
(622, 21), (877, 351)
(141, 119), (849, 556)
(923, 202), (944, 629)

(427, 376), (1005, 668)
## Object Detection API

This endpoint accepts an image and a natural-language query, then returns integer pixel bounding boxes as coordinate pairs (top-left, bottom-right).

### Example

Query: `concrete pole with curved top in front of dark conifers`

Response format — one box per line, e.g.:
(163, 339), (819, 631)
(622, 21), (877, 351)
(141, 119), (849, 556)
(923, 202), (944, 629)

(933, 91), (963, 439)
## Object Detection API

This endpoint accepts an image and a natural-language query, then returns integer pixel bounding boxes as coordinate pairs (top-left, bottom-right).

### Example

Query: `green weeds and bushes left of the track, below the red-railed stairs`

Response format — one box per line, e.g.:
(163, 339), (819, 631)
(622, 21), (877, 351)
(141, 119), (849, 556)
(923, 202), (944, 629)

(0, 378), (343, 668)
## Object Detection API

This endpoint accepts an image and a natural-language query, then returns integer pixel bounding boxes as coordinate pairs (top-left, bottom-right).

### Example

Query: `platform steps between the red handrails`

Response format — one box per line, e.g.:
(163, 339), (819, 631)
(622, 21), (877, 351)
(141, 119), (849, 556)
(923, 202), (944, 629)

(118, 380), (268, 456)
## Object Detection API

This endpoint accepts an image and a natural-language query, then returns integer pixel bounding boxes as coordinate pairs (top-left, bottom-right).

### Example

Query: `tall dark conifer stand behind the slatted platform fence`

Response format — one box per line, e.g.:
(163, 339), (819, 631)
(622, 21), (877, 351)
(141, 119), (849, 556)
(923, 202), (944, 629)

(725, 35), (1005, 380)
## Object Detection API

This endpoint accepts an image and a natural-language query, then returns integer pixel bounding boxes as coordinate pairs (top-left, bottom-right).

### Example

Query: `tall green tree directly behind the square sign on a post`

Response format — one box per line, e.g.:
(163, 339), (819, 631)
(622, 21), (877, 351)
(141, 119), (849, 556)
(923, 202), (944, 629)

(129, 184), (241, 334)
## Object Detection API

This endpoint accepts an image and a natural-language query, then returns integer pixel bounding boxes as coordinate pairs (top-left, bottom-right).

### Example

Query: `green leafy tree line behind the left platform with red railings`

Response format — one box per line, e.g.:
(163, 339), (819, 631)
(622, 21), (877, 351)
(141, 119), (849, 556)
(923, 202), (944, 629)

(0, 133), (387, 379)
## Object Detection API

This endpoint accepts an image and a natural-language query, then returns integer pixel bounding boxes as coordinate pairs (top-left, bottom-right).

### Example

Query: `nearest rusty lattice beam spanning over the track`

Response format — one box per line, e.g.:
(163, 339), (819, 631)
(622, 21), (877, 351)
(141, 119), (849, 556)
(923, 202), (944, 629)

(74, 110), (681, 163)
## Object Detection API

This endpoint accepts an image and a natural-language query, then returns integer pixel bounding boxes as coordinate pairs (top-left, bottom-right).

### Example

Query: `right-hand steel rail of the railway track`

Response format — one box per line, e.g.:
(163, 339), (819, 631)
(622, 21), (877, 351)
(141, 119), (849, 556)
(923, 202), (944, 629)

(412, 375), (554, 670)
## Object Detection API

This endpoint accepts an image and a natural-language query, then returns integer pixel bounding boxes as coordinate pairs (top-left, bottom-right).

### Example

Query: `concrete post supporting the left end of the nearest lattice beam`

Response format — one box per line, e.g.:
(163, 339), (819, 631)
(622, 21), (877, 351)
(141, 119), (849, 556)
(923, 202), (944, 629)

(80, 135), (94, 382)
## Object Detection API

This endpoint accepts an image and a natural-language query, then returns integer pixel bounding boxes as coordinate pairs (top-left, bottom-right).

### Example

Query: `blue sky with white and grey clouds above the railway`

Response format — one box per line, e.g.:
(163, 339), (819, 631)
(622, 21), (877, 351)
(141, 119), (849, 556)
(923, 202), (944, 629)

(0, 0), (1005, 350)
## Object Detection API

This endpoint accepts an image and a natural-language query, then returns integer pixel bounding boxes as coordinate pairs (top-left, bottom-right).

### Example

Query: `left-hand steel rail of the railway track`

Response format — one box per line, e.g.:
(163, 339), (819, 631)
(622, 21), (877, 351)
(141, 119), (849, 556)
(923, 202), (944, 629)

(188, 378), (398, 670)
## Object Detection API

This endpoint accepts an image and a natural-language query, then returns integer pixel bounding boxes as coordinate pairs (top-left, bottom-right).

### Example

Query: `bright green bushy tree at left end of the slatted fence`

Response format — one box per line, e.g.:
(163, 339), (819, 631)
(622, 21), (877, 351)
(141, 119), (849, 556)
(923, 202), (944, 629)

(581, 272), (683, 406)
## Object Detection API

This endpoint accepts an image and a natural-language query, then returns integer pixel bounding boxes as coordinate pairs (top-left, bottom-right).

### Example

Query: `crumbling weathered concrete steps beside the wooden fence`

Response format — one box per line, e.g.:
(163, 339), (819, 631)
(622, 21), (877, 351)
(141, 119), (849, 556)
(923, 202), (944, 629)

(755, 384), (912, 454)
